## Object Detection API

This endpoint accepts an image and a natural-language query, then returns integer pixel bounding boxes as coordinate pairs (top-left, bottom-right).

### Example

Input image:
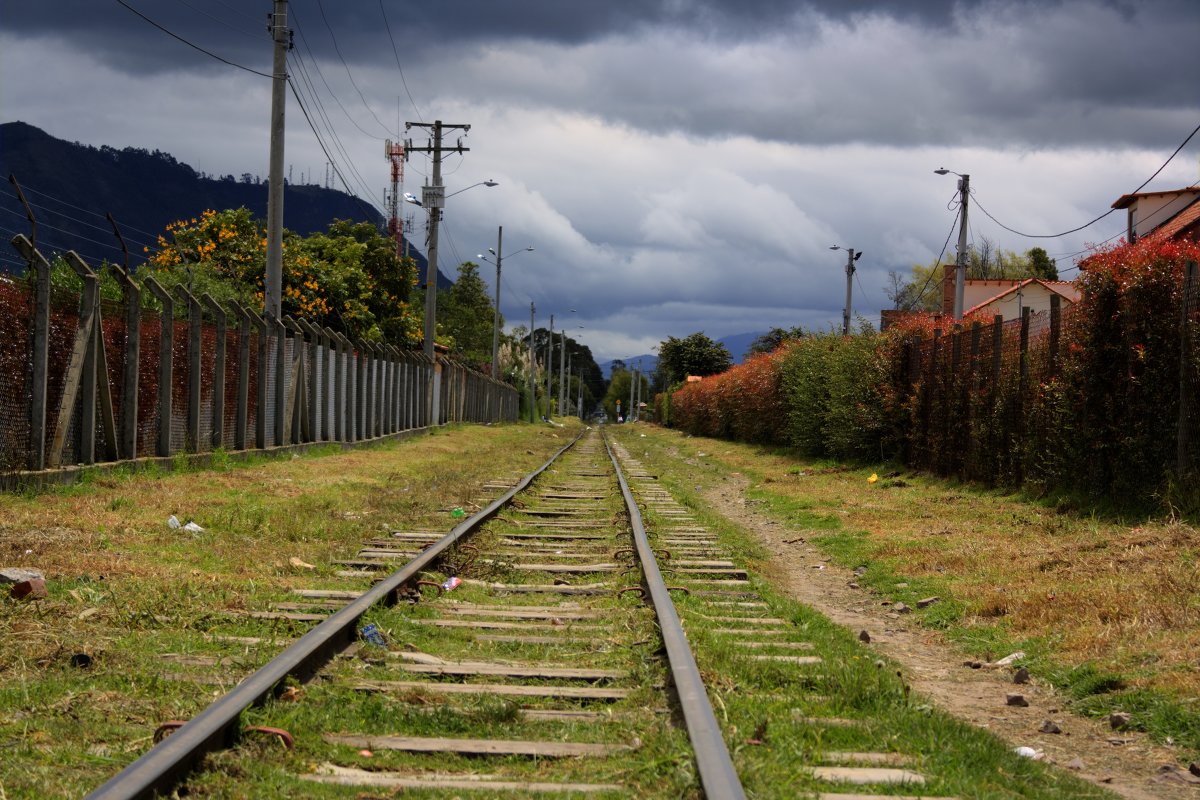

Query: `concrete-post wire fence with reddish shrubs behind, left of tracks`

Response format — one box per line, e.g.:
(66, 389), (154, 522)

(0, 236), (517, 474)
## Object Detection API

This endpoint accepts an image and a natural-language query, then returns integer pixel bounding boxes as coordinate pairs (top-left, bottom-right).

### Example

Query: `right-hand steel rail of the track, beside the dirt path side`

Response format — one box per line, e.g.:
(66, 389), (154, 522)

(604, 437), (746, 800)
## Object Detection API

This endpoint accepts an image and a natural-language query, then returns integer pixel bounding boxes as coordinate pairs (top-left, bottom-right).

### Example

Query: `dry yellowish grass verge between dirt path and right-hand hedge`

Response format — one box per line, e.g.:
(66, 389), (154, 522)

(620, 426), (1200, 767)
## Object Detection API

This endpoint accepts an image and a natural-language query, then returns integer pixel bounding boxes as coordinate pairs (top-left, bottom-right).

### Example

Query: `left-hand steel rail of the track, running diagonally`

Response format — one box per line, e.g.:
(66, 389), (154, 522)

(88, 432), (583, 800)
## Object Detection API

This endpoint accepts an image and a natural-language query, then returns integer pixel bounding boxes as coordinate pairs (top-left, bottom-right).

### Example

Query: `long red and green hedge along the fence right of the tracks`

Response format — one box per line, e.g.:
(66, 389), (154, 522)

(671, 240), (1200, 504)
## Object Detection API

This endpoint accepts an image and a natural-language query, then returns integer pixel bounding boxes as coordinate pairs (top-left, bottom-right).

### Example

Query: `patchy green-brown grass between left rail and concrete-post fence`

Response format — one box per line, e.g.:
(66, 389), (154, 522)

(0, 425), (572, 800)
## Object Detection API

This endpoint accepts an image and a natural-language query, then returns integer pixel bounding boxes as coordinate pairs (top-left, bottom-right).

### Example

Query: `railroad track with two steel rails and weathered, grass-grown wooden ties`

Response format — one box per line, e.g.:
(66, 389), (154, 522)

(89, 432), (955, 800)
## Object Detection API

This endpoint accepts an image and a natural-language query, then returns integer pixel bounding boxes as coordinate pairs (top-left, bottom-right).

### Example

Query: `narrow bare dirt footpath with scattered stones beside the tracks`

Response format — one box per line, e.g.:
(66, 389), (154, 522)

(706, 473), (1200, 800)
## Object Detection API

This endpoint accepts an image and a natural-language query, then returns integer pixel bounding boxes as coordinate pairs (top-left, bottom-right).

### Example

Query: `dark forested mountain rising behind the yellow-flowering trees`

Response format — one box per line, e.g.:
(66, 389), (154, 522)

(0, 122), (451, 288)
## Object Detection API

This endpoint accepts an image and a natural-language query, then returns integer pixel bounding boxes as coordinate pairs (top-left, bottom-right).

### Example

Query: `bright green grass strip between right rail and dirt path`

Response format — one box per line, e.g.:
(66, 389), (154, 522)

(619, 431), (1111, 800)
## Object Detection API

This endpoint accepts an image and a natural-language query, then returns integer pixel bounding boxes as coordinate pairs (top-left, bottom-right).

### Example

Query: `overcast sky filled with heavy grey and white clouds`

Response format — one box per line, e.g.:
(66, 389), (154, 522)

(0, 0), (1200, 360)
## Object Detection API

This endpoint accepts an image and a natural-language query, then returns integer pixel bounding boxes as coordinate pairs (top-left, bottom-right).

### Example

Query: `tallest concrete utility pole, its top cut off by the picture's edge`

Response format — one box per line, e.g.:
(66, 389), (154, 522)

(263, 0), (292, 320)
